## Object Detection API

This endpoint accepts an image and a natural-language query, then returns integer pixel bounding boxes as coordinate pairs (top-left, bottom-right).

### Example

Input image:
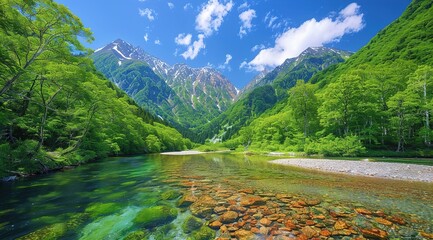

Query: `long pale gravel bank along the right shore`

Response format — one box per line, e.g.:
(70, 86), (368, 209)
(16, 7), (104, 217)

(271, 159), (433, 183)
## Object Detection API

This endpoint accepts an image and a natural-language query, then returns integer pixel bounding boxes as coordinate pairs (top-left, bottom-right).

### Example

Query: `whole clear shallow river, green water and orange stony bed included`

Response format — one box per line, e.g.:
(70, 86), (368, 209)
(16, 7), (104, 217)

(0, 154), (433, 239)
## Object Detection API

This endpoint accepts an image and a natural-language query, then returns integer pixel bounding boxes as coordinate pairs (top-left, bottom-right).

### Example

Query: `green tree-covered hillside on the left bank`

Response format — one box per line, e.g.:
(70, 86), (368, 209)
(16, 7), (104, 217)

(0, 0), (190, 176)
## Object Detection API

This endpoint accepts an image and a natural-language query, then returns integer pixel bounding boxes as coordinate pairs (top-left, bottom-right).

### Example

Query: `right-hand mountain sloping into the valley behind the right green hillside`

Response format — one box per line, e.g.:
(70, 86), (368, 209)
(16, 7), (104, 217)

(196, 47), (352, 142)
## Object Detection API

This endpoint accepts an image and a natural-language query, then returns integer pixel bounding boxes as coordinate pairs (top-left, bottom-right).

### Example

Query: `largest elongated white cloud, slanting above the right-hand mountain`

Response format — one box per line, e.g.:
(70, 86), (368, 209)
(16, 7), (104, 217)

(243, 3), (364, 71)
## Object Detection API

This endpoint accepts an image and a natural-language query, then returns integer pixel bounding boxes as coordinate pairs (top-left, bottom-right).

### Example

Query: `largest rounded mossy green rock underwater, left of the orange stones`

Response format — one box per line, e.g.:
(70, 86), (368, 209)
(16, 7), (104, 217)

(134, 206), (177, 228)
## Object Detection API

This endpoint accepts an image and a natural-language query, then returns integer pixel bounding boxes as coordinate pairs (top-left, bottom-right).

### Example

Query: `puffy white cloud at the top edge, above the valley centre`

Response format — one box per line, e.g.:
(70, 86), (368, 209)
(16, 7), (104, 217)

(195, 0), (233, 36)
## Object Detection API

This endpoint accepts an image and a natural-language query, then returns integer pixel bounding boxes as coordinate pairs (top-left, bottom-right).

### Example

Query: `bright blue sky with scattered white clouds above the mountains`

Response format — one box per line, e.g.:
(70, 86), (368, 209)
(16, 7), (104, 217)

(56, 0), (410, 88)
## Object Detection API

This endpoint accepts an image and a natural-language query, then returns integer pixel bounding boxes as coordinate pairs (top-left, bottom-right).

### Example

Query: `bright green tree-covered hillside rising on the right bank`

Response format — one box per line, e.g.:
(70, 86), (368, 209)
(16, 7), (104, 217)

(226, 0), (433, 156)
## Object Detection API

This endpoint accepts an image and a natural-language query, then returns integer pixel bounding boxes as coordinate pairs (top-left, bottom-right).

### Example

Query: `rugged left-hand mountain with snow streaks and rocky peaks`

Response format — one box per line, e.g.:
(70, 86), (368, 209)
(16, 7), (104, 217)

(92, 39), (237, 129)
